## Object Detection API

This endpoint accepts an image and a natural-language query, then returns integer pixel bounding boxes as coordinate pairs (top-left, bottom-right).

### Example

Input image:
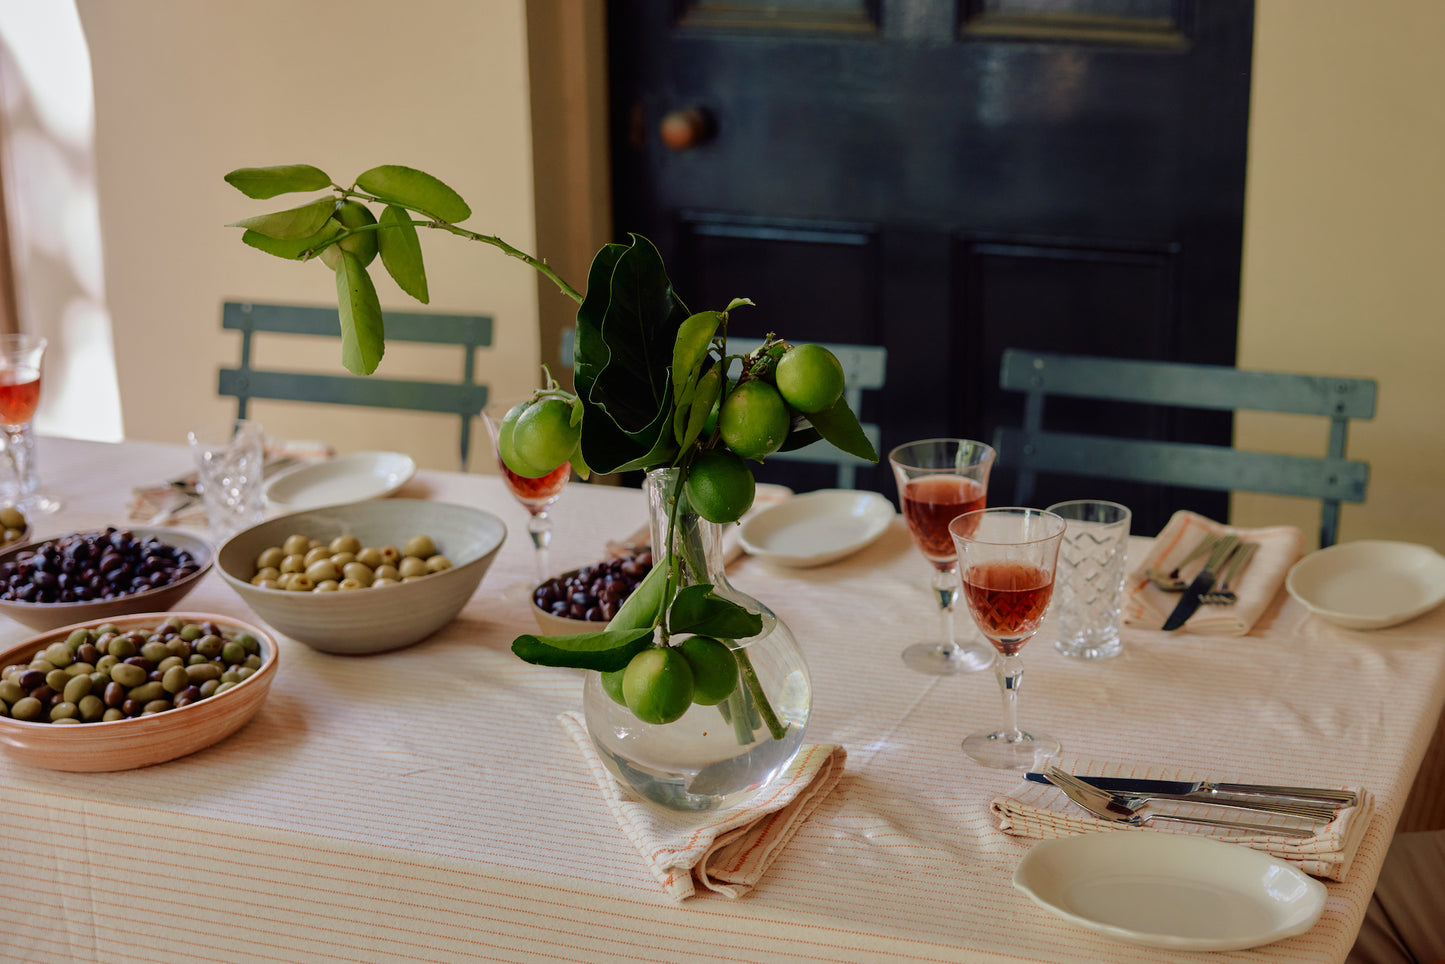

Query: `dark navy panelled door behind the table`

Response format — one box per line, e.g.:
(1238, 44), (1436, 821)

(608, 0), (1253, 532)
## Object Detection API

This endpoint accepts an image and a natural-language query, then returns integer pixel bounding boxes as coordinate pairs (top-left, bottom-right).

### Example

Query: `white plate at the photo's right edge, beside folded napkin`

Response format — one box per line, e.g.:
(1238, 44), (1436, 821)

(1285, 539), (1445, 629)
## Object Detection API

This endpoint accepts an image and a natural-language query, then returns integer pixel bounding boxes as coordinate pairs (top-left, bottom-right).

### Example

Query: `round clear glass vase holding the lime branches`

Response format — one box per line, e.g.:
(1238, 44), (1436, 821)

(582, 468), (812, 811)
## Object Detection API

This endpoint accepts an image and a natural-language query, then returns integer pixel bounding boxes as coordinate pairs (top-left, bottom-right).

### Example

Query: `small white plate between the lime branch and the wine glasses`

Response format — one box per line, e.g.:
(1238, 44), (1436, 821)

(738, 489), (893, 567)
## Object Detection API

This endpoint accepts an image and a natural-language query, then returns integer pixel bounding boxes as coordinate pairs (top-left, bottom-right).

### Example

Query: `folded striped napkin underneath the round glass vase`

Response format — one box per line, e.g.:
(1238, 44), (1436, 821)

(559, 713), (848, 902)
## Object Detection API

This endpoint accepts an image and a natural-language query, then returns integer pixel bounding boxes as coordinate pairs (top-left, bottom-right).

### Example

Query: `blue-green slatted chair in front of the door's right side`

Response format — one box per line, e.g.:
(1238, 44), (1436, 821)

(994, 348), (1376, 546)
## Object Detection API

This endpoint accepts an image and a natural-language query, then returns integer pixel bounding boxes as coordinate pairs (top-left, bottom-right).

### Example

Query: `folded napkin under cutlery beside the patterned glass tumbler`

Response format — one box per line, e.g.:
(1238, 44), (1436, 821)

(1123, 512), (1305, 636)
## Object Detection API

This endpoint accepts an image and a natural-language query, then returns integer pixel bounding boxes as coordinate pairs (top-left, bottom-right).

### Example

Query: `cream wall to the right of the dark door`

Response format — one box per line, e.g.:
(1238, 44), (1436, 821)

(1234, 0), (1445, 551)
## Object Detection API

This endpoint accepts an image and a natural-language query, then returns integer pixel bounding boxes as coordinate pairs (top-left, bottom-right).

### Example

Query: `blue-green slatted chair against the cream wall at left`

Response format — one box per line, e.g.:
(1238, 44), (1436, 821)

(220, 302), (491, 471)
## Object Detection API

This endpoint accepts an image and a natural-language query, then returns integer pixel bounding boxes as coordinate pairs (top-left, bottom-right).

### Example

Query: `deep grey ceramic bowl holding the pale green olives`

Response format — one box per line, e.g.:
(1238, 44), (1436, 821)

(217, 499), (507, 655)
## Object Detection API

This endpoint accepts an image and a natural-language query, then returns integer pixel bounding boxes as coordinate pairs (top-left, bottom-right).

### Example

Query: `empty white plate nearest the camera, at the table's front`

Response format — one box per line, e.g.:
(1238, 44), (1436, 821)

(1013, 830), (1325, 951)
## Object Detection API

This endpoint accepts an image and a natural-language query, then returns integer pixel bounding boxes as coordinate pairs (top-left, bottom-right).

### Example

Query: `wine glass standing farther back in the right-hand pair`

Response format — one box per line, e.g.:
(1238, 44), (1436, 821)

(889, 438), (996, 676)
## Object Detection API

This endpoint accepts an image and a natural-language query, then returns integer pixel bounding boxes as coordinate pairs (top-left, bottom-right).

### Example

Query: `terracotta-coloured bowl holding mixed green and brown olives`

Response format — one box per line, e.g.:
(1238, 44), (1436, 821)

(0, 613), (277, 773)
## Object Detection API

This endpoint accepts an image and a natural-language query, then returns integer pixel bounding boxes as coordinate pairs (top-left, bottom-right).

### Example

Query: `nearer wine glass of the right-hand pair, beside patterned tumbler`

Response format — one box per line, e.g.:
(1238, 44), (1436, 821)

(948, 507), (1066, 770)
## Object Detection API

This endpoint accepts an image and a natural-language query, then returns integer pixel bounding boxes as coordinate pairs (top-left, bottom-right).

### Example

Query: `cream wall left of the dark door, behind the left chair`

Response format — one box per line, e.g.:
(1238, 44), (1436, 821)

(78, 0), (540, 470)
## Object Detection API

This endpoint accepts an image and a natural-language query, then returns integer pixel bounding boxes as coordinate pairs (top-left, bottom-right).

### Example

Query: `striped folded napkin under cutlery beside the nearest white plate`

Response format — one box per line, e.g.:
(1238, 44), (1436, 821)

(990, 762), (1374, 880)
